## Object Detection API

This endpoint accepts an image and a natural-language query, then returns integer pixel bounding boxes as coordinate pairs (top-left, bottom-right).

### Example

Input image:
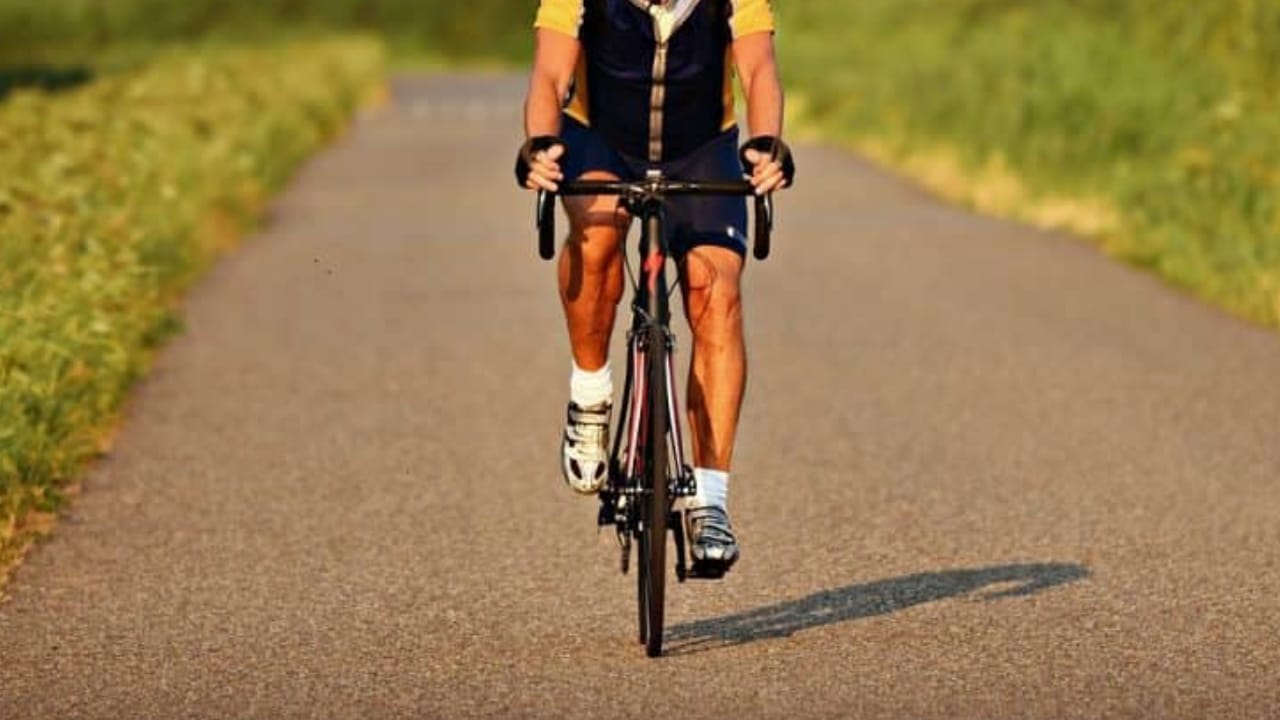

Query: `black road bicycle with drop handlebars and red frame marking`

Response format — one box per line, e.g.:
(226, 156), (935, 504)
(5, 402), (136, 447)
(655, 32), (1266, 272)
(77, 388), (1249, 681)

(536, 170), (773, 657)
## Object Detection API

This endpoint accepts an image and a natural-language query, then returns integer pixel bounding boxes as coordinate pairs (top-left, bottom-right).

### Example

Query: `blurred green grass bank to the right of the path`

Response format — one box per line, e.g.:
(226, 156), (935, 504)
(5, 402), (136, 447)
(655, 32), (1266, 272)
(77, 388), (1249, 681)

(778, 0), (1280, 325)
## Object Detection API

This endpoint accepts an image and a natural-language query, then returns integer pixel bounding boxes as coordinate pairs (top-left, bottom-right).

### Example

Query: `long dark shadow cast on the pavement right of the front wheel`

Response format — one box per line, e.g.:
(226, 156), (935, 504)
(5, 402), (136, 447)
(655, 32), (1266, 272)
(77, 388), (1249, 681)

(667, 562), (1089, 655)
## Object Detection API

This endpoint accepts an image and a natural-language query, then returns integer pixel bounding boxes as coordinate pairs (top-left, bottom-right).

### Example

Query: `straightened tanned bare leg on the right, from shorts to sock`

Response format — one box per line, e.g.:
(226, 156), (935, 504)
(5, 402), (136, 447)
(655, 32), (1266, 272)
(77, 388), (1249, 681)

(681, 247), (746, 471)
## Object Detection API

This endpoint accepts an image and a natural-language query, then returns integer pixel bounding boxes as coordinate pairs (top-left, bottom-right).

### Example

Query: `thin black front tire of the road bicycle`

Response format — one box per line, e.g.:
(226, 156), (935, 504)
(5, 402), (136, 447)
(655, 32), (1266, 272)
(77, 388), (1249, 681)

(639, 323), (669, 657)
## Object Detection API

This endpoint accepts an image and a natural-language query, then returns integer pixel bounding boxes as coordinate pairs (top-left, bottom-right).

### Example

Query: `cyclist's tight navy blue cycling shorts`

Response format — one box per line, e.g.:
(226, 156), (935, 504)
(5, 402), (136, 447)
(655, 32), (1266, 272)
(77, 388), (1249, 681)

(561, 115), (746, 258)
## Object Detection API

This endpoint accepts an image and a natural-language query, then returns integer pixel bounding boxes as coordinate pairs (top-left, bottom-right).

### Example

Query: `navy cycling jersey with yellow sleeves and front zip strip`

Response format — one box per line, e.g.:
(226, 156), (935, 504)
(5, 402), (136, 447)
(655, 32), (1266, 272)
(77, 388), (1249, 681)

(534, 0), (773, 163)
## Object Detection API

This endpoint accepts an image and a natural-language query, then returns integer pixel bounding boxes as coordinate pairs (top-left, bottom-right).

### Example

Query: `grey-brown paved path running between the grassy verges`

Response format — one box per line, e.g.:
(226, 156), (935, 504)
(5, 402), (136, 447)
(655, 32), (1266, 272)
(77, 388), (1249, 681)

(0, 77), (1280, 720)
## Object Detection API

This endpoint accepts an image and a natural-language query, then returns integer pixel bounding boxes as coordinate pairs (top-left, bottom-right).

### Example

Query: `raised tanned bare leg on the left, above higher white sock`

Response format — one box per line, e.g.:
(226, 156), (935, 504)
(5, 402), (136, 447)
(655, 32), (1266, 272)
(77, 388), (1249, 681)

(559, 173), (631, 370)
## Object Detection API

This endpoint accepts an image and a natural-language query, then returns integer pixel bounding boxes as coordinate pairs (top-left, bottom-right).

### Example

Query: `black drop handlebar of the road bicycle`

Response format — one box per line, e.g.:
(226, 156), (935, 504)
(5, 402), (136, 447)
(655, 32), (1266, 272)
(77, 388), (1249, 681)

(538, 178), (773, 260)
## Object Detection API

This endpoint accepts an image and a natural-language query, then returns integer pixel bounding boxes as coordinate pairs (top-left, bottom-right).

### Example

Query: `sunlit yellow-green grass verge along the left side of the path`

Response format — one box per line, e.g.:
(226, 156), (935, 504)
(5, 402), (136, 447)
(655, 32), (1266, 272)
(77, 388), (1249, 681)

(0, 38), (383, 565)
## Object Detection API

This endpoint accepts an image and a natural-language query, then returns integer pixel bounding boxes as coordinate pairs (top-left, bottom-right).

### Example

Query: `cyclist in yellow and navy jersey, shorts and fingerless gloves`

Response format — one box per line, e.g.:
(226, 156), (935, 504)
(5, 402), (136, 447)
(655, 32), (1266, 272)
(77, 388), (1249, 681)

(516, 0), (794, 571)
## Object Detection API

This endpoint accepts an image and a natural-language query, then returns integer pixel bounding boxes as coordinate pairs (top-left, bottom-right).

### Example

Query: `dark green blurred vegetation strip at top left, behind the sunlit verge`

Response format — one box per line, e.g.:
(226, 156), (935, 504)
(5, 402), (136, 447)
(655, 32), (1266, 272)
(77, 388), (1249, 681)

(0, 0), (536, 65)
